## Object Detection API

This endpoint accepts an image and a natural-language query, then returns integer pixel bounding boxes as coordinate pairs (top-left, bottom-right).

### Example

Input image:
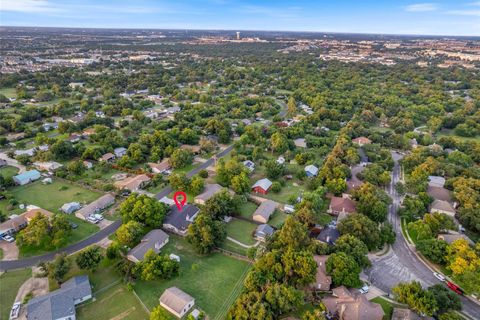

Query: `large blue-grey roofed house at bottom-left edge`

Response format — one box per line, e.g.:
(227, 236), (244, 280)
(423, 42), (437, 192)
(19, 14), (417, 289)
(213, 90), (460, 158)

(26, 276), (92, 320)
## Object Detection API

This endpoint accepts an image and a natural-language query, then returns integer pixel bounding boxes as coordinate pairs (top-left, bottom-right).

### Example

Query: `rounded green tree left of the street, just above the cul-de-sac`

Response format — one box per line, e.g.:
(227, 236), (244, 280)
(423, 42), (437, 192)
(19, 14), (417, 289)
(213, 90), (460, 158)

(338, 213), (383, 250)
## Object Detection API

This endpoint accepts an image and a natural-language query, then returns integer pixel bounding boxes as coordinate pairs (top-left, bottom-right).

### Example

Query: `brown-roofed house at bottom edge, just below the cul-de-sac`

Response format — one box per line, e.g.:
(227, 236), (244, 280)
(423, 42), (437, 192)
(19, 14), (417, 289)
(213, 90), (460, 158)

(322, 286), (385, 320)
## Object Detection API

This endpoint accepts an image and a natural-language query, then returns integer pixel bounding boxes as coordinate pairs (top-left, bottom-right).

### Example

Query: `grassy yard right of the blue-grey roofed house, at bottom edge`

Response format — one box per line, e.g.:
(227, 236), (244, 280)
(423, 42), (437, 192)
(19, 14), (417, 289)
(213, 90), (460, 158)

(77, 283), (149, 320)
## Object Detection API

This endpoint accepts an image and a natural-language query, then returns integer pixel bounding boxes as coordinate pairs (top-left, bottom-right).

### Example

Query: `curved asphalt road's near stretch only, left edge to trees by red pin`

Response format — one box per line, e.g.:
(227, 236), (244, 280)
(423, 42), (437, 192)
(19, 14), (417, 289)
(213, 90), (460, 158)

(0, 220), (122, 271)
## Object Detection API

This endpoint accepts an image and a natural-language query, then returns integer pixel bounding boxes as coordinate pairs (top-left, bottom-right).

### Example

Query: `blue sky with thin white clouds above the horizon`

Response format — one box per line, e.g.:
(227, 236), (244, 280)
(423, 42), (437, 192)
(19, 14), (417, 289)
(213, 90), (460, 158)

(0, 0), (480, 36)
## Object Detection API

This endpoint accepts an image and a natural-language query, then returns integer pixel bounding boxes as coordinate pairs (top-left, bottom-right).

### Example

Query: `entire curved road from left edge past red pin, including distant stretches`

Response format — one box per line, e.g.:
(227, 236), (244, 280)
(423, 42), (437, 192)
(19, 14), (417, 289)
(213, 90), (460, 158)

(0, 145), (233, 271)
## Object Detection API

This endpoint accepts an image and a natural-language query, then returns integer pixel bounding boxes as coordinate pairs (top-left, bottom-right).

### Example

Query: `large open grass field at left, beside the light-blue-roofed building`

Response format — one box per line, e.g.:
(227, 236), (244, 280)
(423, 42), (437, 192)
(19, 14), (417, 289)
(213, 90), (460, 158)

(10, 180), (100, 212)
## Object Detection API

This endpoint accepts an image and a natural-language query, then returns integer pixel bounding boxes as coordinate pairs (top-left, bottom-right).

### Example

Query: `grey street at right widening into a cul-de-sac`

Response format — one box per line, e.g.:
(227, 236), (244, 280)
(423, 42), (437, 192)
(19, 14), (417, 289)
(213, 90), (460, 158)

(365, 152), (480, 319)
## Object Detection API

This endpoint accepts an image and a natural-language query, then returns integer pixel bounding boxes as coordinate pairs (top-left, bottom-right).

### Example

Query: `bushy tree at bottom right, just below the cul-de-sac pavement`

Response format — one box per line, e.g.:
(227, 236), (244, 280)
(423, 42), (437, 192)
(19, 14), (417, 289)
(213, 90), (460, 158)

(392, 281), (438, 316)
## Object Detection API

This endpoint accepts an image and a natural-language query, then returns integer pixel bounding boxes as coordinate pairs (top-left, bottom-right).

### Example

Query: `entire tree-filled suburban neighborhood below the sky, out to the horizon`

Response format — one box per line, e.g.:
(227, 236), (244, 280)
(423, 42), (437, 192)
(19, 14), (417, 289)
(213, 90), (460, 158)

(0, 24), (480, 320)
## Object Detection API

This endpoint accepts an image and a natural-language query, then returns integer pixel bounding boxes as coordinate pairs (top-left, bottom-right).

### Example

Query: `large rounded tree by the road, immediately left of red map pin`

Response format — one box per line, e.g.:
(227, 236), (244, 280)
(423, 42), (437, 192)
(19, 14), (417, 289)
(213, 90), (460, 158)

(120, 193), (168, 228)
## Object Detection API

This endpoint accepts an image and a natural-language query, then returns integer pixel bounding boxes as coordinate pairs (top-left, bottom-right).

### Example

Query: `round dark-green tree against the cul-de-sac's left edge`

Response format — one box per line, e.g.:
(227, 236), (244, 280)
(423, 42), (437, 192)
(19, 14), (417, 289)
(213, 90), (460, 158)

(326, 252), (362, 287)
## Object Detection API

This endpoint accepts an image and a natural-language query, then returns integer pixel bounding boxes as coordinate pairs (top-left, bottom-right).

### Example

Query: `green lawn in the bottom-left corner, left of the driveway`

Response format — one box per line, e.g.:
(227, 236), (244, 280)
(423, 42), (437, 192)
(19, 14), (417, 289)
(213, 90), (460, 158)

(0, 269), (32, 319)
